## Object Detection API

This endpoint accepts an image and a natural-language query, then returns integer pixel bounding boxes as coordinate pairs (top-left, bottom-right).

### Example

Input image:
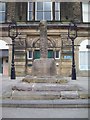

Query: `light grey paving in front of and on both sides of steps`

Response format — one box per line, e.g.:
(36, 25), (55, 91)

(0, 76), (89, 118)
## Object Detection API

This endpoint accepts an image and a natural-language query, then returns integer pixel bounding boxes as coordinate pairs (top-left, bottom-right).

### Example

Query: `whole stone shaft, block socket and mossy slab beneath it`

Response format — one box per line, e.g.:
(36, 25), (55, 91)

(22, 20), (67, 83)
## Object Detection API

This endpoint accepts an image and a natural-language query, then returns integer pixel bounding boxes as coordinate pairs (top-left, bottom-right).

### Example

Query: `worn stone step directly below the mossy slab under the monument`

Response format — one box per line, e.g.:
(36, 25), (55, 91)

(12, 83), (84, 92)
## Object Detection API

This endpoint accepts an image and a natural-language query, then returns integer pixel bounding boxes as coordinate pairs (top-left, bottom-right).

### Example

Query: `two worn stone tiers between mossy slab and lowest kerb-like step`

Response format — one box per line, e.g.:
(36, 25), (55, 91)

(2, 82), (89, 100)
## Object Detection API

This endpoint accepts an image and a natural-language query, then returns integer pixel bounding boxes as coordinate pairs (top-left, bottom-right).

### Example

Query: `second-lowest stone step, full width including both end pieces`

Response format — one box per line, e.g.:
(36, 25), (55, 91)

(2, 90), (89, 100)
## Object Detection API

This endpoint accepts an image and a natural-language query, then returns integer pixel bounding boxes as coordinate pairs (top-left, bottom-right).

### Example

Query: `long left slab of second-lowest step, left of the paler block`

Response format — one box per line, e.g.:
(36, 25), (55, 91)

(11, 91), (61, 100)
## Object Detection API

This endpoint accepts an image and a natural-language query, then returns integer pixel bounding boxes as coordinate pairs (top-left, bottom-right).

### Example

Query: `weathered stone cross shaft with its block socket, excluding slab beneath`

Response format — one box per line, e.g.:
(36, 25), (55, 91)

(32, 21), (56, 77)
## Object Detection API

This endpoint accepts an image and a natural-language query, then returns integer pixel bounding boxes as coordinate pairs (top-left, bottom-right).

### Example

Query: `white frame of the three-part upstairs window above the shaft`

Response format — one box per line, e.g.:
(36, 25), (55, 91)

(27, 1), (61, 21)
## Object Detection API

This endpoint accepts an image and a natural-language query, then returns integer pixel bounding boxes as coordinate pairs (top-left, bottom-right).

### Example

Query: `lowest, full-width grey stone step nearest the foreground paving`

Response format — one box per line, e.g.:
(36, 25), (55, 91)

(0, 99), (90, 108)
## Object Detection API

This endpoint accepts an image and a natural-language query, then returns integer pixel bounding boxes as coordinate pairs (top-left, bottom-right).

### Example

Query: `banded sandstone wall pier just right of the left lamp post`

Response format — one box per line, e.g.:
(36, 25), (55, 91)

(14, 35), (27, 76)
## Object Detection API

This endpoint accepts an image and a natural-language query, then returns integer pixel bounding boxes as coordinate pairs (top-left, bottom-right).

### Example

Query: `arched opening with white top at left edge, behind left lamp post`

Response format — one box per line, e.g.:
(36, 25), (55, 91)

(0, 40), (9, 75)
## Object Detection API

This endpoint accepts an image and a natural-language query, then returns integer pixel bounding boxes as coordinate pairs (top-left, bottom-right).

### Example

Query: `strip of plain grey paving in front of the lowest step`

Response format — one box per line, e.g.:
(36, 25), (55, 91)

(2, 108), (88, 118)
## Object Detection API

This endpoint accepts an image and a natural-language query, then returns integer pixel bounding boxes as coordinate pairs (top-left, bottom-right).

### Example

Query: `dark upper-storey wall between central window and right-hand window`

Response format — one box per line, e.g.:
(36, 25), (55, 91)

(60, 2), (81, 21)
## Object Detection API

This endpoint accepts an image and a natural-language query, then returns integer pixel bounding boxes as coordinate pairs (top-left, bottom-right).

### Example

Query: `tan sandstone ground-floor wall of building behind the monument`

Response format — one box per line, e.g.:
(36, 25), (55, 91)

(1, 28), (88, 76)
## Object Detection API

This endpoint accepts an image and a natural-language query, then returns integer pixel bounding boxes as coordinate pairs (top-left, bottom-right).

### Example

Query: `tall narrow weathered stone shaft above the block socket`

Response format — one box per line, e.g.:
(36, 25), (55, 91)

(39, 21), (48, 58)
